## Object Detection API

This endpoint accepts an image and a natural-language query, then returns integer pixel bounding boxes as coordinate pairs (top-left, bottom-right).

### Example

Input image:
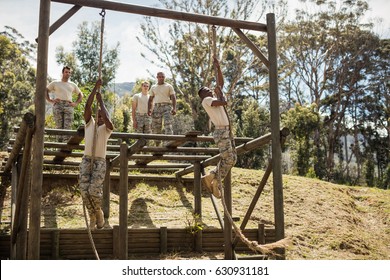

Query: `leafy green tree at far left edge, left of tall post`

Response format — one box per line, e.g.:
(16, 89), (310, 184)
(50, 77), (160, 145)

(0, 27), (35, 149)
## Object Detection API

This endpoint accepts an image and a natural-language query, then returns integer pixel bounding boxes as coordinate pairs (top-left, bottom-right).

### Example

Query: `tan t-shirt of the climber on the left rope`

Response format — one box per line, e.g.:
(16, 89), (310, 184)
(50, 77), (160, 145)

(84, 117), (112, 158)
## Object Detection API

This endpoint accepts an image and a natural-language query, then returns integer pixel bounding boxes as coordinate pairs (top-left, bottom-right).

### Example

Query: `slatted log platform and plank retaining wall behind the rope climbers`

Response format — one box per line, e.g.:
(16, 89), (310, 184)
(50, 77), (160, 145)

(0, 123), (283, 259)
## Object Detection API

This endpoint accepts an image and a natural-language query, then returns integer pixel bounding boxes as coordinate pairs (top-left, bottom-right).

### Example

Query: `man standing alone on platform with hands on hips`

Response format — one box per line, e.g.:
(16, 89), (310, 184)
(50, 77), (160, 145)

(46, 66), (83, 142)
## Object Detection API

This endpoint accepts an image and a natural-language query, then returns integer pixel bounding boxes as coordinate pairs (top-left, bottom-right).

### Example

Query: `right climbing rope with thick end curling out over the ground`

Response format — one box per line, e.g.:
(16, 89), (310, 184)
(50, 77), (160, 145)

(212, 25), (290, 255)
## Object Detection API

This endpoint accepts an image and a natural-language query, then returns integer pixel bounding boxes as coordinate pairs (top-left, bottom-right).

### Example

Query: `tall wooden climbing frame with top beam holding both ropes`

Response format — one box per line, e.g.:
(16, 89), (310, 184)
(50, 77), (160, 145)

(3, 0), (284, 260)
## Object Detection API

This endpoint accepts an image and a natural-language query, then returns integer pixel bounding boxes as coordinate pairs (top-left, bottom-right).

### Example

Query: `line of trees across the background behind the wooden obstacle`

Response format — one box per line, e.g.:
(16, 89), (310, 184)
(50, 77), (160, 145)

(0, 0), (390, 189)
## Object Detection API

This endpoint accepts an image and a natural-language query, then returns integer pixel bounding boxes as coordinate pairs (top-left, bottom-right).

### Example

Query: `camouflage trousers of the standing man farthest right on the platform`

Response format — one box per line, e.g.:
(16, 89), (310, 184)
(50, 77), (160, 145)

(152, 104), (173, 146)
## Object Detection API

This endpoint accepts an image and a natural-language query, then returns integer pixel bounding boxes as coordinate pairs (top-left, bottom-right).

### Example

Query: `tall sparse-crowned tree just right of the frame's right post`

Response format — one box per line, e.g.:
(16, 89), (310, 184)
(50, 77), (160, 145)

(281, 0), (384, 180)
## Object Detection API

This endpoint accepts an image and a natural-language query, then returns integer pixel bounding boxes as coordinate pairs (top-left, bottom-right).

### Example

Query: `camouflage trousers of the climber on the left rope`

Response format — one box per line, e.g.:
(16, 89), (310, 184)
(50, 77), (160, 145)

(79, 156), (106, 216)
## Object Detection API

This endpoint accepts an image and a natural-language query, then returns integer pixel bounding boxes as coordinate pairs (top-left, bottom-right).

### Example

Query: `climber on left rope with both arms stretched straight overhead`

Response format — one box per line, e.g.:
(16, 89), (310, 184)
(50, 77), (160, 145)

(79, 79), (114, 229)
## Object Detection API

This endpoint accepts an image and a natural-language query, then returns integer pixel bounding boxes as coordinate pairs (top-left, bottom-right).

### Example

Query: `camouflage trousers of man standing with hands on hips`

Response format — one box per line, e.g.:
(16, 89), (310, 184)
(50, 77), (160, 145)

(53, 100), (74, 142)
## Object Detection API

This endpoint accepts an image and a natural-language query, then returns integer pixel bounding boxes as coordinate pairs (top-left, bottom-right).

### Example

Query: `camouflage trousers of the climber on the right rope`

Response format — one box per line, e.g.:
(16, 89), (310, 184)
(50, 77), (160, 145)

(211, 129), (237, 182)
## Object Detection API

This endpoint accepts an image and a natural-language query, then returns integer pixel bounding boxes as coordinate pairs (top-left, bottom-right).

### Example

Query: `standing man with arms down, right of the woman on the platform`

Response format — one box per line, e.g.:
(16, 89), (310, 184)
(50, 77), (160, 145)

(148, 72), (176, 146)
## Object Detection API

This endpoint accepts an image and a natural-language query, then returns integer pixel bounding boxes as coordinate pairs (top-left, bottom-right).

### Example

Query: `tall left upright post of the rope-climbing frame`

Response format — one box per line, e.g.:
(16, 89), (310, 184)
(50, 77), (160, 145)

(28, 0), (51, 260)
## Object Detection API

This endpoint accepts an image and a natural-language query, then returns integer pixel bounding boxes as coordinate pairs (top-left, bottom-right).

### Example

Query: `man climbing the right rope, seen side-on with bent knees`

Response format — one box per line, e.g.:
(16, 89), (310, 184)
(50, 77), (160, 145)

(198, 59), (237, 198)
